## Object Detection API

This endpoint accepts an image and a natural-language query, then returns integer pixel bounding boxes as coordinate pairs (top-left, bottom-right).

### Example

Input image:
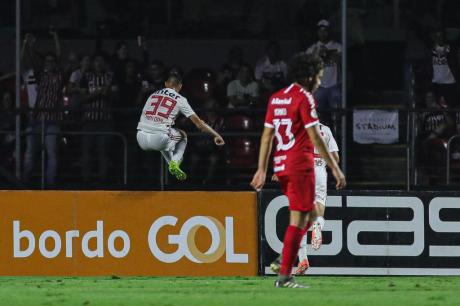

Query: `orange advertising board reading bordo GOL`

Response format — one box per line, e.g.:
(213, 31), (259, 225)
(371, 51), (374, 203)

(0, 191), (257, 276)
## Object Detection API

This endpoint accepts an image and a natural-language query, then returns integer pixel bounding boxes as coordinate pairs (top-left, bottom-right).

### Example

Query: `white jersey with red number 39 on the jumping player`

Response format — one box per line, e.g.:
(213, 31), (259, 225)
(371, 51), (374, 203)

(137, 88), (195, 133)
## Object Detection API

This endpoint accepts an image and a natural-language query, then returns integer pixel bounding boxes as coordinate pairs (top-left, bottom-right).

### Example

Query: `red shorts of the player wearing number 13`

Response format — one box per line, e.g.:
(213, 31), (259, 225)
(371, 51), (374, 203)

(278, 174), (315, 212)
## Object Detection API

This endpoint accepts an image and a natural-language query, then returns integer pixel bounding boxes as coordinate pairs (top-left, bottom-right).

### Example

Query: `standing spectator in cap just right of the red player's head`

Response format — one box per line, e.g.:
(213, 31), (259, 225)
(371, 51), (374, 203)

(306, 19), (342, 110)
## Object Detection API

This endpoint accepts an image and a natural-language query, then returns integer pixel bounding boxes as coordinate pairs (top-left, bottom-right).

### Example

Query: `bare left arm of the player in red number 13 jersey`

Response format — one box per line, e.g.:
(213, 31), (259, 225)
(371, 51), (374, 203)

(251, 127), (275, 191)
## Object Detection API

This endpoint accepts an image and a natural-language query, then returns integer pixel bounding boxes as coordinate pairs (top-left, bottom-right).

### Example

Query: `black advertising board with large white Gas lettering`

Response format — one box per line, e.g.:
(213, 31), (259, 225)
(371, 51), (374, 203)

(259, 190), (460, 275)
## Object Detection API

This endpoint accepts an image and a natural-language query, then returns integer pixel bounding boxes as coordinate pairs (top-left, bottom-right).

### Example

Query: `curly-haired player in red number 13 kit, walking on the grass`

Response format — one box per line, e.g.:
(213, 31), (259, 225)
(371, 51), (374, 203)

(251, 53), (346, 288)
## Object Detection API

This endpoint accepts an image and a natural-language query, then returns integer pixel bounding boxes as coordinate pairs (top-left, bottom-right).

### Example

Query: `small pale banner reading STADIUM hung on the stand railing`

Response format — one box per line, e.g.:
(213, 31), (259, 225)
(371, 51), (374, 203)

(353, 109), (399, 144)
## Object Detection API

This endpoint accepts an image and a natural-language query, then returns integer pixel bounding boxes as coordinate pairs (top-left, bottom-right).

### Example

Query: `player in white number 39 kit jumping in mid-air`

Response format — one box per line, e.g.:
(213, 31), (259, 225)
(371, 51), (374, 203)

(137, 73), (225, 180)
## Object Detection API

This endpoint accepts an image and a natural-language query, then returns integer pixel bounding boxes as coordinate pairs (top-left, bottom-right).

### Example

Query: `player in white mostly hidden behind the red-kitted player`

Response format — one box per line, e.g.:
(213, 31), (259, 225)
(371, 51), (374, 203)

(296, 123), (340, 274)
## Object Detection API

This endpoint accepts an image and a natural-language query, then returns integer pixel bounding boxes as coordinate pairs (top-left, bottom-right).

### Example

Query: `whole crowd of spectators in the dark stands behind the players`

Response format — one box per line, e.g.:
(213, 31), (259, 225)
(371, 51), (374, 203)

(0, 1), (460, 188)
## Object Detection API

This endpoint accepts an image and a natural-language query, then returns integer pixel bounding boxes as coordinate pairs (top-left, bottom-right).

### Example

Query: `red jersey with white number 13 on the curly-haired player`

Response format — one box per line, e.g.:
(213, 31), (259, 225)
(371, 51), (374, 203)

(264, 83), (319, 176)
